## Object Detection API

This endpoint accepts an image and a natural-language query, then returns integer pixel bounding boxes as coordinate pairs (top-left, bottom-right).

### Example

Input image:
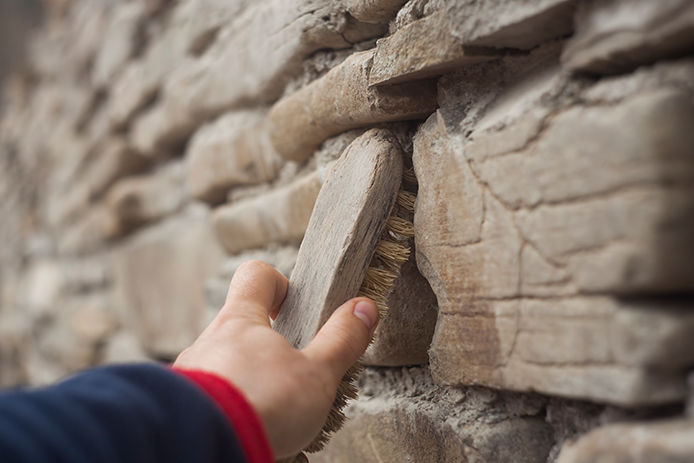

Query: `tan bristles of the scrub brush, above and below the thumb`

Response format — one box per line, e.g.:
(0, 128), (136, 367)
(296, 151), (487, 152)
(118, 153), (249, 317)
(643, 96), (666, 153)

(304, 183), (417, 453)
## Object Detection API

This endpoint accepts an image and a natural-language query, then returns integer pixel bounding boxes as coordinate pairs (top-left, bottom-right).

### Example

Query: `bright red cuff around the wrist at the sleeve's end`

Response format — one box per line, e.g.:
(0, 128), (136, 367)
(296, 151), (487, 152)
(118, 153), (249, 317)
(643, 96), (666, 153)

(172, 368), (275, 463)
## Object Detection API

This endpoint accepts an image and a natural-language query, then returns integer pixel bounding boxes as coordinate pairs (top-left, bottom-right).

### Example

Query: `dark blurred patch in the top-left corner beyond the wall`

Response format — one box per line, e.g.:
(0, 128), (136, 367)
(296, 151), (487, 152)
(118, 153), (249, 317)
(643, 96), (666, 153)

(0, 0), (43, 94)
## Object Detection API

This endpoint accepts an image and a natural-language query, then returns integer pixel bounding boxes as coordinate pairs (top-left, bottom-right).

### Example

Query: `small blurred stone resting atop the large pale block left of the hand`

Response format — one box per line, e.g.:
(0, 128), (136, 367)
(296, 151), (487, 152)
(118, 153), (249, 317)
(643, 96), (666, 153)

(106, 163), (185, 233)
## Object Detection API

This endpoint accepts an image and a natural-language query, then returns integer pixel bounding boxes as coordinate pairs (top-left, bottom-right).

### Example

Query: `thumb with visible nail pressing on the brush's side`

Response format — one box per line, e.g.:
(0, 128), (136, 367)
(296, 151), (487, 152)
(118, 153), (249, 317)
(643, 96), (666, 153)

(304, 297), (378, 381)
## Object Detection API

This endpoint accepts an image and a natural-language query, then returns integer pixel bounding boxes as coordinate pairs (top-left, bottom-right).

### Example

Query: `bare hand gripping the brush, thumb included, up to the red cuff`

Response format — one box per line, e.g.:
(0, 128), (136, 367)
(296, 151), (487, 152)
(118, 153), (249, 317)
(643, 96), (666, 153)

(174, 261), (378, 458)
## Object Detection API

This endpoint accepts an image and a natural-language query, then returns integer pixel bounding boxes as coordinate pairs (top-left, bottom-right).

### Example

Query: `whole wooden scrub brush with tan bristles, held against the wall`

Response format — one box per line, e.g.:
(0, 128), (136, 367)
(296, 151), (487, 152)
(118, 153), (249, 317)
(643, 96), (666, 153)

(273, 129), (416, 462)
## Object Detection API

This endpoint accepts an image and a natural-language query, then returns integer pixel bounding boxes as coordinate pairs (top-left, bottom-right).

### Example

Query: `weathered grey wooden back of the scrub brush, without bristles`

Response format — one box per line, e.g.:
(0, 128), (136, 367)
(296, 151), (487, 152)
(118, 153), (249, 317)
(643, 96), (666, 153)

(273, 129), (402, 349)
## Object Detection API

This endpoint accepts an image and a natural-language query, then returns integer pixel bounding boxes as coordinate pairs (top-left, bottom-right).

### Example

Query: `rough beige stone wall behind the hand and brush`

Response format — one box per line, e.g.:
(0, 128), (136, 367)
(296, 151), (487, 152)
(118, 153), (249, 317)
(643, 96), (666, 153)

(0, 0), (694, 463)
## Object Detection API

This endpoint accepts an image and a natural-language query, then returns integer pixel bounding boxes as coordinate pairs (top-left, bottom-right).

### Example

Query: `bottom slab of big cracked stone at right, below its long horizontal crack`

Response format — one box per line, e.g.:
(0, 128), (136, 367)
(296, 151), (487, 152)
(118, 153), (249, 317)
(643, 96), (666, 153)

(432, 298), (694, 406)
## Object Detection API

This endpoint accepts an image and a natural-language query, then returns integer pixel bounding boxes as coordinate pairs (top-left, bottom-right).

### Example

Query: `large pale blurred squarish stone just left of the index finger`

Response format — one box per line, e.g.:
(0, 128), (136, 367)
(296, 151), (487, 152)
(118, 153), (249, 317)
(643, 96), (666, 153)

(114, 206), (222, 358)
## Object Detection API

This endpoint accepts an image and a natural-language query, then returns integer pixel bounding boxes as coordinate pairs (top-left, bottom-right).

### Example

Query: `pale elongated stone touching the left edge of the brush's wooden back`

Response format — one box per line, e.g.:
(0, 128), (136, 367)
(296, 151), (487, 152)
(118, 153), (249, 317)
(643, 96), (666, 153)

(214, 172), (321, 254)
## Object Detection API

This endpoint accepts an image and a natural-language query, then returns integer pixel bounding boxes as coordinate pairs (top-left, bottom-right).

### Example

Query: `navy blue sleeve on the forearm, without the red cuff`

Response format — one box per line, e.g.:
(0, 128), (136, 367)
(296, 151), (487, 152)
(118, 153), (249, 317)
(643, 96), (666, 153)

(0, 364), (246, 463)
